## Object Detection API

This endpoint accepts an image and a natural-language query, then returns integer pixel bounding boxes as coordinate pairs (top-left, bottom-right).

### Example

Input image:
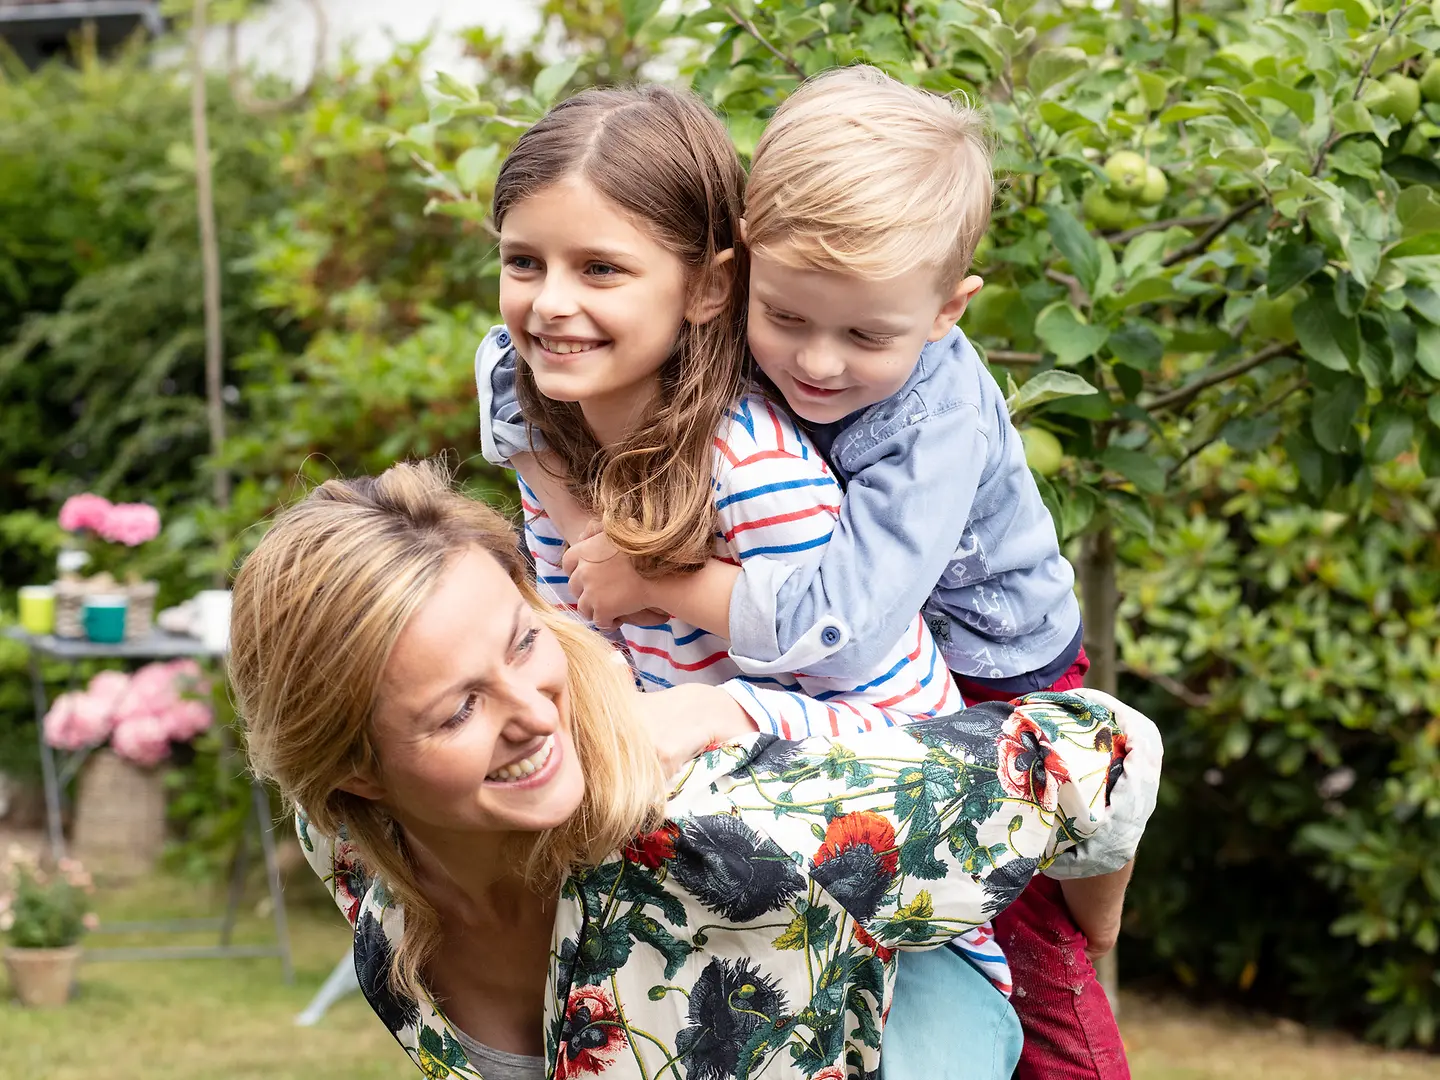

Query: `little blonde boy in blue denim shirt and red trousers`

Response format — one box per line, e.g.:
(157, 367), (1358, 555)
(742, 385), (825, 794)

(477, 68), (1129, 1080)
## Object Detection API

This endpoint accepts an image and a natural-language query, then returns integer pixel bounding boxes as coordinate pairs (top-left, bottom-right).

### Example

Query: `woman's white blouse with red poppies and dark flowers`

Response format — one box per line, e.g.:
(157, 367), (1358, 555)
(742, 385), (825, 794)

(298, 693), (1158, 1080)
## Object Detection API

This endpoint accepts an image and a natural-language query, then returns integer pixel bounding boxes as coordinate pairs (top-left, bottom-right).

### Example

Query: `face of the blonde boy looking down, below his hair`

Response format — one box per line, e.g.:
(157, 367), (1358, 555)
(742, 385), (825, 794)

(749, 251), (981, 423)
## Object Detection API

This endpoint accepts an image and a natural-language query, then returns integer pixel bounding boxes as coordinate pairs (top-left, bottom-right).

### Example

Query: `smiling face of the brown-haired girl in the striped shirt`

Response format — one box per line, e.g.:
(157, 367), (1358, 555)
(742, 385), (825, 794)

(500, 176), (690, 444)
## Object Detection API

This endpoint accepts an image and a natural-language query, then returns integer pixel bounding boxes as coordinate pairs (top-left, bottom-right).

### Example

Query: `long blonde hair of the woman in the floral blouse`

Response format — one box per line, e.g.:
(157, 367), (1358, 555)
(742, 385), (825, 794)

(229, 461), (664, 996)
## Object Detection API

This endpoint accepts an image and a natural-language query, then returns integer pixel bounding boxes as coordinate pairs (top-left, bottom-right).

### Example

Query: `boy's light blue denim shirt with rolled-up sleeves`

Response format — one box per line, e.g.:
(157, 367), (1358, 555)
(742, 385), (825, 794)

(475, 327), (1080, 678)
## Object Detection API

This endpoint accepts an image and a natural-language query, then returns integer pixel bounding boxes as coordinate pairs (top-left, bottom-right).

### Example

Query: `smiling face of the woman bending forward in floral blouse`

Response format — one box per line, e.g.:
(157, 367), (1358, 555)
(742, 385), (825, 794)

(356, 547), (585, 834)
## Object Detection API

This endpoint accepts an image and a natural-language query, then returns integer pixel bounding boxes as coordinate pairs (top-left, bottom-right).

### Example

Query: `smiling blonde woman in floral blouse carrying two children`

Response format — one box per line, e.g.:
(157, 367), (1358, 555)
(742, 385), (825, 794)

(230, 464), (1158, 1080)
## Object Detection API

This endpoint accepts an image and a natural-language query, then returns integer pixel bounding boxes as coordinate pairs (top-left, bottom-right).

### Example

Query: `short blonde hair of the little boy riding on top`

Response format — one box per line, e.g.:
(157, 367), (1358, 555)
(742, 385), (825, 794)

(744, 65), (995, 289)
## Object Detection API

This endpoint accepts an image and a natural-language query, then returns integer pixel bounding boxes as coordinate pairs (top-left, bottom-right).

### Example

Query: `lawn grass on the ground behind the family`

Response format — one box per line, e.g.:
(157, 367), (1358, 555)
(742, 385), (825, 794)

(0, 878), (1440, 1080)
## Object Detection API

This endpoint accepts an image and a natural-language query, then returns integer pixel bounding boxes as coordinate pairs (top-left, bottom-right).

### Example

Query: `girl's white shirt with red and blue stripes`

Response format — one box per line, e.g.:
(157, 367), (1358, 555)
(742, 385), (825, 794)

(520, 393), (1011, 996)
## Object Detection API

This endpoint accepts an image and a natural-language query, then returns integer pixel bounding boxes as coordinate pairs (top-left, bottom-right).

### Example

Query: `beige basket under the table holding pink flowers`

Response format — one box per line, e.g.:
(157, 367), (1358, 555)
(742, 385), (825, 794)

(75, 747), (166, 881)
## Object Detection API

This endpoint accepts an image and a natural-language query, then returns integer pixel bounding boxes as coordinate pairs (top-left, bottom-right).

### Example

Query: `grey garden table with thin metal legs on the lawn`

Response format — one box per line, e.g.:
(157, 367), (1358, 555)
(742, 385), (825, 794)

(6, 626), (295, 982)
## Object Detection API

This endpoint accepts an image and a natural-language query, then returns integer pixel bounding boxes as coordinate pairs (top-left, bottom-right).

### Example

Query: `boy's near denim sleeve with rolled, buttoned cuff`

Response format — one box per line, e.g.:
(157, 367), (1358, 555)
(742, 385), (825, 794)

(729, 405), (988, 677)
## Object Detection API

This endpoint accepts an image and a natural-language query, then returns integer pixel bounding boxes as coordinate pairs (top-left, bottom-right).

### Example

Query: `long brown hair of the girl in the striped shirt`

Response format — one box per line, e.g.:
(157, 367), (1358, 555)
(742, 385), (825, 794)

(494, 86), (749, 575)
